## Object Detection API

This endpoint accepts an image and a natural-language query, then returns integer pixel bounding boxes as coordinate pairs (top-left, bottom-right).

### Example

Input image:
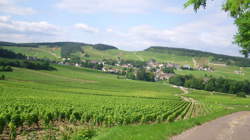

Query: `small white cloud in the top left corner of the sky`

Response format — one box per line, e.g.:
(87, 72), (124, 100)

(0, 0), (35, 15)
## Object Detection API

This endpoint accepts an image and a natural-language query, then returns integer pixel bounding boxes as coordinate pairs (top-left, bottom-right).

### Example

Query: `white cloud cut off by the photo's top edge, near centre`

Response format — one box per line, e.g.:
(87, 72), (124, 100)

(57, 0), (162, 13)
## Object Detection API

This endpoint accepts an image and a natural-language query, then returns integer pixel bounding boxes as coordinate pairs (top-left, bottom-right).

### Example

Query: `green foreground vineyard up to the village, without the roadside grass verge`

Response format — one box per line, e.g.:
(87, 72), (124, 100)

(0, 65), (247, 139)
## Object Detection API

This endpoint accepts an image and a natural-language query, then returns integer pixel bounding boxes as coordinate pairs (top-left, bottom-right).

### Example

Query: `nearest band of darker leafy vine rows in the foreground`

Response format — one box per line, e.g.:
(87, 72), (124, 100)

(0, 95), (209, 137)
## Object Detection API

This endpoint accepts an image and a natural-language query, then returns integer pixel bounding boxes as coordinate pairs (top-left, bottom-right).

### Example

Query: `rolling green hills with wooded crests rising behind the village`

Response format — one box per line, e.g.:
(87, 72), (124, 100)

(0, 42), (250, 80)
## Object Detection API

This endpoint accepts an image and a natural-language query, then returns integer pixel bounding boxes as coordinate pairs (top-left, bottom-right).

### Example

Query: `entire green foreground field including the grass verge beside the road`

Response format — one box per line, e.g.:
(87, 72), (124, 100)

(0, 65), (250, 140)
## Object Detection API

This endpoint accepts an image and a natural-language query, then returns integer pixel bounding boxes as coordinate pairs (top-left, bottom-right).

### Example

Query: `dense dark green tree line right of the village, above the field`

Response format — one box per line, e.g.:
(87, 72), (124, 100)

(169, 75), (250, 95)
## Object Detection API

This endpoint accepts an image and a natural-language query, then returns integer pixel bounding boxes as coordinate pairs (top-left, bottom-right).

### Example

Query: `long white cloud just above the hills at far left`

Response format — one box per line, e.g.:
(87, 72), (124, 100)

(0, 16), (62, 42)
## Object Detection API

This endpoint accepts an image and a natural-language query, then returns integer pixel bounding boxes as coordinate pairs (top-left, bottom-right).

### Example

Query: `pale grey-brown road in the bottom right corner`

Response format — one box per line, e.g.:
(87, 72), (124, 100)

(171, 111), (250, 140)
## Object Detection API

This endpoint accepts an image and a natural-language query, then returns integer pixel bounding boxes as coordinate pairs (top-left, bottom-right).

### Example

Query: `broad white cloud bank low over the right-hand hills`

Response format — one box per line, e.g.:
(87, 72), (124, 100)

(101, 13), (239, 55)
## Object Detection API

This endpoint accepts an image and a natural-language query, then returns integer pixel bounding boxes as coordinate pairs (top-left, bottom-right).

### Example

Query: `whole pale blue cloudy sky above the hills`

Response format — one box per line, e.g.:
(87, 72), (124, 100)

(0, 0), (243, 56)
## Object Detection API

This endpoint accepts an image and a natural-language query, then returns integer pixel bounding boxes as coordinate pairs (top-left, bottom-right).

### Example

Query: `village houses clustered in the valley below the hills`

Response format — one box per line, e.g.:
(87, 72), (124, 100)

(58, 58), (213, 81)
